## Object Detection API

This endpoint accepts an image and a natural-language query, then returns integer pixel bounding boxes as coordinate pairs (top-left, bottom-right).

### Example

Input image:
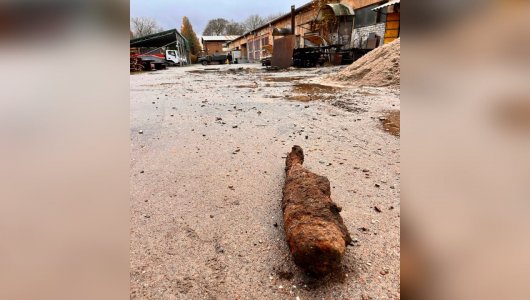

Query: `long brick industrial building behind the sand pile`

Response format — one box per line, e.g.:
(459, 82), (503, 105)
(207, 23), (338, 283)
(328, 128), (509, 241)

(227, 0), (400, 64)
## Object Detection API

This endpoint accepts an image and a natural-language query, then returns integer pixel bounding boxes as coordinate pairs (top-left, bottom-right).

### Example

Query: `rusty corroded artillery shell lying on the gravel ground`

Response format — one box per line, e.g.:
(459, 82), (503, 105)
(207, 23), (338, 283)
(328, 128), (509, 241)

(282, 146), (351, 275)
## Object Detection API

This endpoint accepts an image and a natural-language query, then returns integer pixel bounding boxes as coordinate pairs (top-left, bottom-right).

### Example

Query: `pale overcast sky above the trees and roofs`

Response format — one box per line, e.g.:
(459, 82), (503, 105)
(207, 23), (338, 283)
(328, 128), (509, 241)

(130, 0), (310, 36)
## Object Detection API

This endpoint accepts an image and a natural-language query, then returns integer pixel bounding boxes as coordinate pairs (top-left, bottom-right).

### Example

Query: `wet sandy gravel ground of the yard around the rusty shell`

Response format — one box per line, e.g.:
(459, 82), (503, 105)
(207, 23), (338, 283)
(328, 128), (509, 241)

(130, 65), (400, 299)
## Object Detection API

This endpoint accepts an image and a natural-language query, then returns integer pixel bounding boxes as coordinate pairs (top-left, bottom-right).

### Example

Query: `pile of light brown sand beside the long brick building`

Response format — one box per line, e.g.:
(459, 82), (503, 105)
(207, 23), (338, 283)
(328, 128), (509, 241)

(323, 39), (401, 87)
